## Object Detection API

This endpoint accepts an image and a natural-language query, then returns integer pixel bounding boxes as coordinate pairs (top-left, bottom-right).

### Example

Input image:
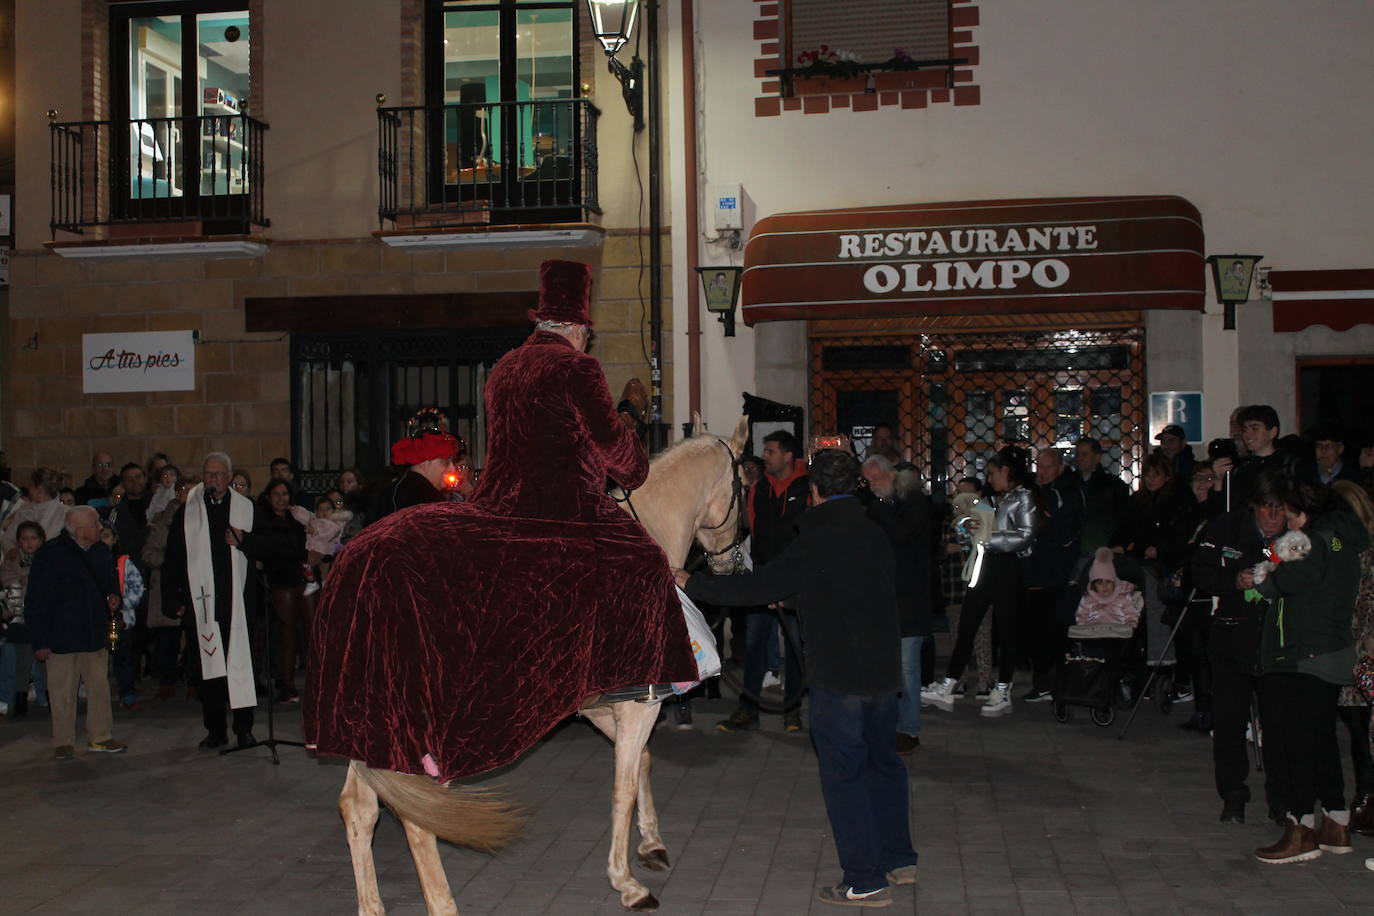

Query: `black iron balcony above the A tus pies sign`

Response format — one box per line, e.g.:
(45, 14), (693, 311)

(49, 114), (268, 242)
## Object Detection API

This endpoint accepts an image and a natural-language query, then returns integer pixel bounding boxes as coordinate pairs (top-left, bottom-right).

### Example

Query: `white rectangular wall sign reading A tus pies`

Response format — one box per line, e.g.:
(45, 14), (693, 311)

(81, 331), (195, 394)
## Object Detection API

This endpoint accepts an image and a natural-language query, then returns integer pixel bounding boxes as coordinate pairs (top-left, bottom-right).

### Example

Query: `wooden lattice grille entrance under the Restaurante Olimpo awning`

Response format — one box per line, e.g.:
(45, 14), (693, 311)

(811, 328), (1150, 494)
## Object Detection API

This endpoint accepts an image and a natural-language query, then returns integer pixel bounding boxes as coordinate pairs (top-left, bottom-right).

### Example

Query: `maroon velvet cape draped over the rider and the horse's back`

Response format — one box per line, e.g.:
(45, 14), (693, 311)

(304, 331), (697, 781)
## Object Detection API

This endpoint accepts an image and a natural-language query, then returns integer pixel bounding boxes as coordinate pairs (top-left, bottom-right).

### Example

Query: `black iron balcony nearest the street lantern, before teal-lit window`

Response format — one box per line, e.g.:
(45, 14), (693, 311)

(376, 99), (600, 236)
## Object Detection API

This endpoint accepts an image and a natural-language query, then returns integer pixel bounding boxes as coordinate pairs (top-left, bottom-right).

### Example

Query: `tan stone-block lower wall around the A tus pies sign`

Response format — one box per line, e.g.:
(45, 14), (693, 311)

(4, 232), (671, 483)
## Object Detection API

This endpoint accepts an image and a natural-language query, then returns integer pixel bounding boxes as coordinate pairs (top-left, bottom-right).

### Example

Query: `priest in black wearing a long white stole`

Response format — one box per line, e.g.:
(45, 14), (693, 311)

(164, 452), (257, 748)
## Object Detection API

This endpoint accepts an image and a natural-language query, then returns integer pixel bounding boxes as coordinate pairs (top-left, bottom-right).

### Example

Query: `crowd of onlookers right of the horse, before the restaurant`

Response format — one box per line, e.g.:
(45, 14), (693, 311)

(698, 405), (1374, 878)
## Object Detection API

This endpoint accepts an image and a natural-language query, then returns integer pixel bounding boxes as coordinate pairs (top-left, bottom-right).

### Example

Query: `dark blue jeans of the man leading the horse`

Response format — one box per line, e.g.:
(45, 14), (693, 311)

(811, 687), (916, 894)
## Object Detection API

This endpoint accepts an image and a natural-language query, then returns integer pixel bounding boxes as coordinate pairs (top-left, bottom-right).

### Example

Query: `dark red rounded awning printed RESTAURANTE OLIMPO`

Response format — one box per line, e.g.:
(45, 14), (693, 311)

(742, 196), (1205, 324)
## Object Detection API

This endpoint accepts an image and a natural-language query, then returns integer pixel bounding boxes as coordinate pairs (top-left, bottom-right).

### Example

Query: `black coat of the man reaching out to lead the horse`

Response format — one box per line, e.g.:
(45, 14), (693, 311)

(686, 497), (901, 696)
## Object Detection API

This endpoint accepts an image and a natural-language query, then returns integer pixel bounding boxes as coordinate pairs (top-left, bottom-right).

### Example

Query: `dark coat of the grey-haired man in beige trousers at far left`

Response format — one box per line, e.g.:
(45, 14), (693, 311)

(23, 531), (120, 655)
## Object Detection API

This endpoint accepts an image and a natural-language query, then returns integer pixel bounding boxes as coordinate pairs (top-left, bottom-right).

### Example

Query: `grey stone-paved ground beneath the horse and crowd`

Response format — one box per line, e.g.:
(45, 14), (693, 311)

(0, 683), (1374, 916)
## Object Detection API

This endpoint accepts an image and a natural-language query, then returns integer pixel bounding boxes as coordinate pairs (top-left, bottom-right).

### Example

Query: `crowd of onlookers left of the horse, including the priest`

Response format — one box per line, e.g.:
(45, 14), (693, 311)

(0, 439), (473, 759)
